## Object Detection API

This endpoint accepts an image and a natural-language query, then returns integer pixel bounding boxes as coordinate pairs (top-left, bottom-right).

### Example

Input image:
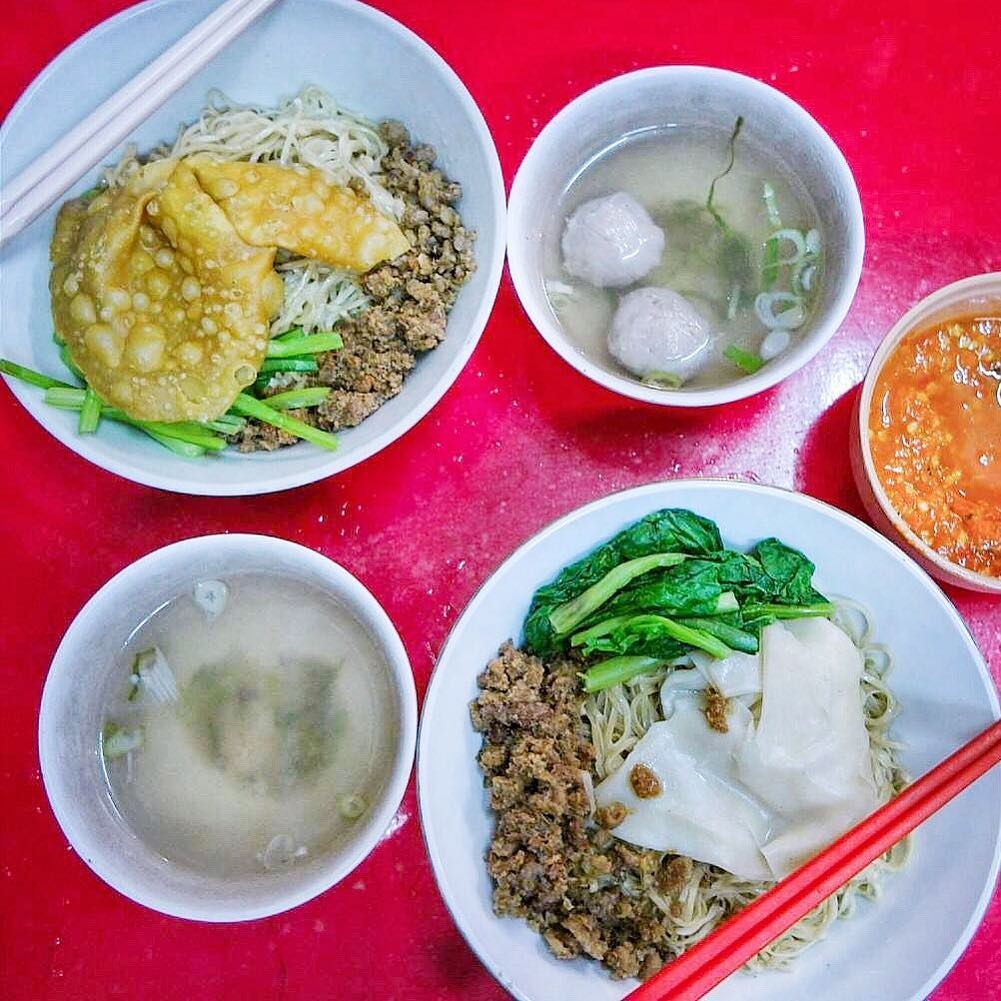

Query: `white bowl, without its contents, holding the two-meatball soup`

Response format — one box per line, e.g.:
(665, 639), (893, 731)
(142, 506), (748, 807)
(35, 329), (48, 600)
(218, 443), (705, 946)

(508, 66), (865, 406)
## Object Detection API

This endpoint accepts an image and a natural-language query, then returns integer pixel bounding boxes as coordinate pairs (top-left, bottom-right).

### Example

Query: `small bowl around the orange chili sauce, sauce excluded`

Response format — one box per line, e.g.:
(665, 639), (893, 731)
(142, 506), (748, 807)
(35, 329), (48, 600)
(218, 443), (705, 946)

(851, 271), (1001, 595)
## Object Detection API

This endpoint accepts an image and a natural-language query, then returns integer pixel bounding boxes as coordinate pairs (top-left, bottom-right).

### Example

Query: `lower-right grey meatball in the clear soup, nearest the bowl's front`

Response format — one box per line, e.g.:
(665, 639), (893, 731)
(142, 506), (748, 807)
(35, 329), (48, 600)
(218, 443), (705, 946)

(609, 287), (713, 382)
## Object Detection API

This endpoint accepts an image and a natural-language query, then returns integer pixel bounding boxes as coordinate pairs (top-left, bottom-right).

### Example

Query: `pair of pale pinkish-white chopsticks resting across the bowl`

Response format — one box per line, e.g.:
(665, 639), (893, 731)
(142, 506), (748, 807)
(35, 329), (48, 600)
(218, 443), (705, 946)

(0, 0), (277, 246)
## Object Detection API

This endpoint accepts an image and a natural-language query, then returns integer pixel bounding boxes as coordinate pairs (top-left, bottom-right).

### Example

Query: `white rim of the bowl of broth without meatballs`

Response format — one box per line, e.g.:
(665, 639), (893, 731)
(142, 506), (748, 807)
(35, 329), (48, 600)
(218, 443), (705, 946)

(38, 534), (417, 924)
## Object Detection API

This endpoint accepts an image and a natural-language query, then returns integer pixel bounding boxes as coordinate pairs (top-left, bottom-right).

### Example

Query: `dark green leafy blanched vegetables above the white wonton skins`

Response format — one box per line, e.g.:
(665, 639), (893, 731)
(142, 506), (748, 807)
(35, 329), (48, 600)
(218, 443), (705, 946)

(524, 509), (832, 691)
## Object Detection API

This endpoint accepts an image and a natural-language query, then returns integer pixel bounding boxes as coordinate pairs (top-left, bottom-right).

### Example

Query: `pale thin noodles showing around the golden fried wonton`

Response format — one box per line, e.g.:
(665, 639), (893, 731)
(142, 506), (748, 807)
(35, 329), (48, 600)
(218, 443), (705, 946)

(104, 86), (394, 335)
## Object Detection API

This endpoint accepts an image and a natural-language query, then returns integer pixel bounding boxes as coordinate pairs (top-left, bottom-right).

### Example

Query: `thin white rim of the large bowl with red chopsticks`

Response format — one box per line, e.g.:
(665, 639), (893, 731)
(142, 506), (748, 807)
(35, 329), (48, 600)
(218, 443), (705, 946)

(416, 477), (1001, 1001)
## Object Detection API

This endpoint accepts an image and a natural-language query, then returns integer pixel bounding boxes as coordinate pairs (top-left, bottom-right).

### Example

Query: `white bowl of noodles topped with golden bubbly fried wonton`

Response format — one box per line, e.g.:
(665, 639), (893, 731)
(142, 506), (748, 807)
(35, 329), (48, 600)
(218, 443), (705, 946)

(0, 0), (505, 495)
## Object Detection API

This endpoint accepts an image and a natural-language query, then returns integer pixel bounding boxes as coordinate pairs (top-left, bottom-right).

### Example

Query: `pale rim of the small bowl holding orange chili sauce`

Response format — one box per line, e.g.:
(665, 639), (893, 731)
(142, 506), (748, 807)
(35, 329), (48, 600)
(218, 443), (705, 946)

(859, 271), (1001, 594)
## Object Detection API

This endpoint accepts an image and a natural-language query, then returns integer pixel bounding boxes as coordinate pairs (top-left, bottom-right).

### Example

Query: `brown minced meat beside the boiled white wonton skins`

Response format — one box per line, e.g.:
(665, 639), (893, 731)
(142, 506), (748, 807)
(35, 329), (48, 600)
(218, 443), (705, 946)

(470, 644), (692, 979)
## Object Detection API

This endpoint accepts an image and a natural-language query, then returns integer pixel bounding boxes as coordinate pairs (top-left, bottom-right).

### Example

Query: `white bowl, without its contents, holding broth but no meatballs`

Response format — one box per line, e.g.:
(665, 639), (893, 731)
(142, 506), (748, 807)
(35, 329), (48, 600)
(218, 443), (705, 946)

(38, 535), (417, 921)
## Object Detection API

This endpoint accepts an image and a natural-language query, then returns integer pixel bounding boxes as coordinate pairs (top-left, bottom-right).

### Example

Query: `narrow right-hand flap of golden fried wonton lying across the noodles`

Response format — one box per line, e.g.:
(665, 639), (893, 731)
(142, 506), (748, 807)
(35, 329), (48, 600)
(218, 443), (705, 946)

(191, 158), (409, 272)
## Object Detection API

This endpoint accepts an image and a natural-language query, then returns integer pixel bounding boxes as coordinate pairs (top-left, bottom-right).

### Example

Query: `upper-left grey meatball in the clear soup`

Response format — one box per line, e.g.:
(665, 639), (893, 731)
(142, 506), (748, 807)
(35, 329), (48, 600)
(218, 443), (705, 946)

(562, 191), (664, 288)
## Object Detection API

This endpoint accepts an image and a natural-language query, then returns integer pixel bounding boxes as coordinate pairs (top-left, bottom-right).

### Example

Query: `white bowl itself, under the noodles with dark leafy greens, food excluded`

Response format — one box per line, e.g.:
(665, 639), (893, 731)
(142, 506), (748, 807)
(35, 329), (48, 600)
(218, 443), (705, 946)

(417, 480), (1001, 1001)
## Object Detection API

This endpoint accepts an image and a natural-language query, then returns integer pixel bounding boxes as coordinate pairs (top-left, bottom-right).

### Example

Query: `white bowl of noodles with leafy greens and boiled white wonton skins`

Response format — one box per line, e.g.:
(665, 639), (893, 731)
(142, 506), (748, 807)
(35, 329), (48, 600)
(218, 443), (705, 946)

(417, 480), (1001, 1001)
